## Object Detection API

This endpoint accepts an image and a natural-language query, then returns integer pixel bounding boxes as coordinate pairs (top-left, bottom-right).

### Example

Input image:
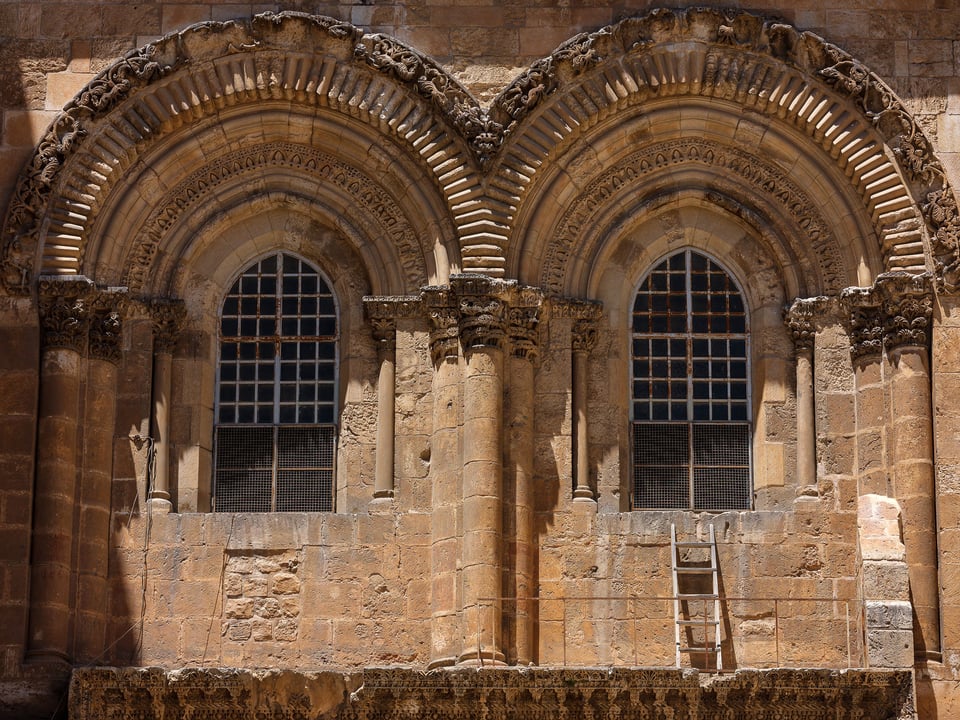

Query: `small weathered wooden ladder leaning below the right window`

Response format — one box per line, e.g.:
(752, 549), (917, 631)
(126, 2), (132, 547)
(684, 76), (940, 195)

(670, 524), (723, 671)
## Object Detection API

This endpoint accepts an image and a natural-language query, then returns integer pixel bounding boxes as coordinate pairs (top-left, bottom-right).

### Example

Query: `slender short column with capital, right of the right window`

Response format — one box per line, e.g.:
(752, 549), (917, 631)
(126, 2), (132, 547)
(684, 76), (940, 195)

(785, 298), (826, 495)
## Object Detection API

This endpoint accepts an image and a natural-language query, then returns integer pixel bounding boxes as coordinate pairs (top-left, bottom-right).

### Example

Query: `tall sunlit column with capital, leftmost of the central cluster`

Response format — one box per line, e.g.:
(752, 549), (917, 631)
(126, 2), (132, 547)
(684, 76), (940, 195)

(423, 289), (461, 667)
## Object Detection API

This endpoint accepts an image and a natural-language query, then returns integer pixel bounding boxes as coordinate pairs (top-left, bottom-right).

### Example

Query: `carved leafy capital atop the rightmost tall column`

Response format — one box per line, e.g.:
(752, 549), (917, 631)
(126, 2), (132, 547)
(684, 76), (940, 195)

(876, 272), (933, 350)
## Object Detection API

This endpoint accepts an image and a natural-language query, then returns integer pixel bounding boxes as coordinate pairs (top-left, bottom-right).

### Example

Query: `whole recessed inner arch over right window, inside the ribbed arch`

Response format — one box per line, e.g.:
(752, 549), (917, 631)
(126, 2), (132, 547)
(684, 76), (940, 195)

(532, 133), (864, 297)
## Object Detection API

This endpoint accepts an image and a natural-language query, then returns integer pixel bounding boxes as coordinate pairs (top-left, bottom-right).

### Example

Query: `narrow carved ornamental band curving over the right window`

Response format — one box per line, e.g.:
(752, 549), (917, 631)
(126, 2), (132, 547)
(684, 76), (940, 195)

(541, 139), (847, 293)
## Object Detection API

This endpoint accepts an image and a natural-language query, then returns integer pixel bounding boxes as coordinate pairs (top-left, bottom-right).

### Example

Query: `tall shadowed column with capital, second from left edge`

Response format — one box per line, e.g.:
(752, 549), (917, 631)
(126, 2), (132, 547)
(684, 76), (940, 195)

(74, 292), (124, 662)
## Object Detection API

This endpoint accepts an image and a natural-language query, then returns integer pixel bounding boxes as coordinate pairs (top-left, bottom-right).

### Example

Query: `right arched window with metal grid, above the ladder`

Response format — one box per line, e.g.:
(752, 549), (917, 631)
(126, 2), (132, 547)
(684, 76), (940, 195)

(632, 249), (752, 510)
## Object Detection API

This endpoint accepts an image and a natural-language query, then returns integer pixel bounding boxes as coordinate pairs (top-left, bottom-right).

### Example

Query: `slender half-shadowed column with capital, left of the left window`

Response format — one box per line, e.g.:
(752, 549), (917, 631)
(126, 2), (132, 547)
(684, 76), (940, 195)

(148, 300), (186, 513)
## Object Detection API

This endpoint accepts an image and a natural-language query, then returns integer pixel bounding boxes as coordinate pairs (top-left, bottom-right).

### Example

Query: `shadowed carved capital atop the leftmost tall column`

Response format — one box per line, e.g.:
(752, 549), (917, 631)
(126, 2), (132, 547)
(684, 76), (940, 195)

(39, 276), (95, 353)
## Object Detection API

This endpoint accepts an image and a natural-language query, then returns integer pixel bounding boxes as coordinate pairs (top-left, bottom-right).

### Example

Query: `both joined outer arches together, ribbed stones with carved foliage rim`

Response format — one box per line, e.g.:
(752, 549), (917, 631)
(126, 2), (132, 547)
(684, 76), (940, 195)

(0, 9), (960, 293)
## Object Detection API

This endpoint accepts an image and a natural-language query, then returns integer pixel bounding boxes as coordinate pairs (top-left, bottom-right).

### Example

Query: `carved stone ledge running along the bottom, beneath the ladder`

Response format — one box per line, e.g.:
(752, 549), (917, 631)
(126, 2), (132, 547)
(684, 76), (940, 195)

(70, 668), (916, 720)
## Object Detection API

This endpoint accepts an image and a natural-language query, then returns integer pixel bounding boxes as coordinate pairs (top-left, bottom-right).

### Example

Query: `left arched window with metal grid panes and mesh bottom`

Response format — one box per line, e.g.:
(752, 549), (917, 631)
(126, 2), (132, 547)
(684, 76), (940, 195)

(213, 253), (338, 512)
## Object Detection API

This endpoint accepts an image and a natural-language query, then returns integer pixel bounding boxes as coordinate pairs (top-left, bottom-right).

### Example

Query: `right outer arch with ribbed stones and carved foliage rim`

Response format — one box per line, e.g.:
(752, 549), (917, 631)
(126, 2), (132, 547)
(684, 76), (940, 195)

(489, 9), (960, 286)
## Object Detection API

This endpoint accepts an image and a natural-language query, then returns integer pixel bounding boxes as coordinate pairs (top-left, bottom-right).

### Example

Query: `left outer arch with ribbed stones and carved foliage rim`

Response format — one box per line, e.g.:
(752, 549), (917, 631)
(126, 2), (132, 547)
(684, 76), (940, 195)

(0, 13), (496, 292)
